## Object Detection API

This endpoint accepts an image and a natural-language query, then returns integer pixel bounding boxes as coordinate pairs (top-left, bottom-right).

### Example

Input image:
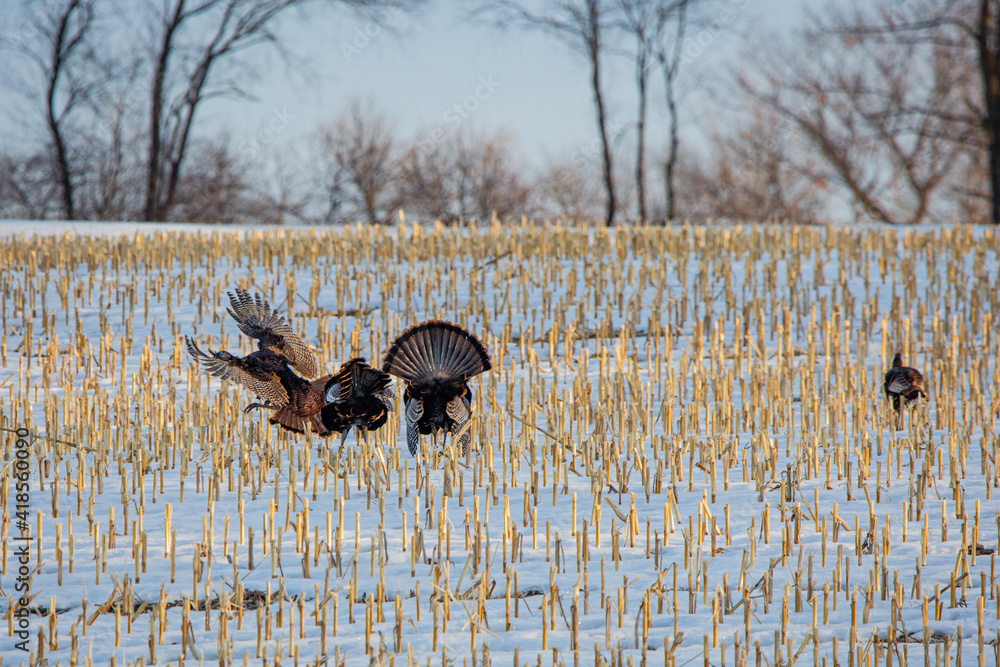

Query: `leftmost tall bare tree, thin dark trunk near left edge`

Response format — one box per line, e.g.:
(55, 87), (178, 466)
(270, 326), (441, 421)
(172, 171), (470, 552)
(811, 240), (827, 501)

(3, 0), (161, 224)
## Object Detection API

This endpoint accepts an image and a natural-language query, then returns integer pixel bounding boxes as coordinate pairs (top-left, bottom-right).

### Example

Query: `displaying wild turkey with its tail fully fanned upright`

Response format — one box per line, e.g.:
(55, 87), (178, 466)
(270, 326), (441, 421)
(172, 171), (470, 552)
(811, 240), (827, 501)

(382, 320), (492, 455)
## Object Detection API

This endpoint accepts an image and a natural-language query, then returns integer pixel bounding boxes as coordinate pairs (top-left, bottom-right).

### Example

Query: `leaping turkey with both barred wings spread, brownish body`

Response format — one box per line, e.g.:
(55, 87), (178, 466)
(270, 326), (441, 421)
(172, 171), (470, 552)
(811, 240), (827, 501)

(185, 289), (332, 436)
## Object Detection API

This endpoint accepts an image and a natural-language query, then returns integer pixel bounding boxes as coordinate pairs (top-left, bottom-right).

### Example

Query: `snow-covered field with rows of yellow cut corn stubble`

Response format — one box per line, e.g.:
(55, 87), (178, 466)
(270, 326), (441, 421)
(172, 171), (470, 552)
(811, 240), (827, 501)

(0, 223), (1000, 666)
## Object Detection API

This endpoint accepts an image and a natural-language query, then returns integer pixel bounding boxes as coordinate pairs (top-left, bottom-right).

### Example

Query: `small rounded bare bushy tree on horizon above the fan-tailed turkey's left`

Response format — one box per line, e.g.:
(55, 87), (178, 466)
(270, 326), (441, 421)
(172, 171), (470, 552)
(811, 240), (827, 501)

(323, 99), (396, 223)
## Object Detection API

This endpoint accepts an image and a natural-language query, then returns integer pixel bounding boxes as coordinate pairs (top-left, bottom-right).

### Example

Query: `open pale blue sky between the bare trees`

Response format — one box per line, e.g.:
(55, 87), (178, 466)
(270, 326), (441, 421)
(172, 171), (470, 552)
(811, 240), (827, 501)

(208, 0), (802, 162)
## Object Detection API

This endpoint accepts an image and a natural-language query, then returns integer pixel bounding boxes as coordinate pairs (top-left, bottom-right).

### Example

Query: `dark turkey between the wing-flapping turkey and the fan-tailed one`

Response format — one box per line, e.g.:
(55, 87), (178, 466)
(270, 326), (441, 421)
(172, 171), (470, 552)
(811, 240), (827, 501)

(320, 357), (396, 447)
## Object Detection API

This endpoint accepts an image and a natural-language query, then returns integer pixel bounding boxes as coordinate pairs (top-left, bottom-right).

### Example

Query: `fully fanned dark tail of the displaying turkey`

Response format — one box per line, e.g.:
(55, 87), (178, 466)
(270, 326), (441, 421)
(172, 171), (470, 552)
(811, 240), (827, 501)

(382, 320), (492, 382)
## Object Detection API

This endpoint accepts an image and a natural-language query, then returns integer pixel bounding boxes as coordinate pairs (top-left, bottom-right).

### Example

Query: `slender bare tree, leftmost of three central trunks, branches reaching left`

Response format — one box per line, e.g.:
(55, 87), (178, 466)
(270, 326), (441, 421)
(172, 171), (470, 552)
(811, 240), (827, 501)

(475, 0), (617, 227)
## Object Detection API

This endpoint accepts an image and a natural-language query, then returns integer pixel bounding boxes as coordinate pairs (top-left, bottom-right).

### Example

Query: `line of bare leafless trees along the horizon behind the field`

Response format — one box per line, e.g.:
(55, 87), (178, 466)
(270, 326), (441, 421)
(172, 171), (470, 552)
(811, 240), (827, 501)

(0, 0), (1000, 225)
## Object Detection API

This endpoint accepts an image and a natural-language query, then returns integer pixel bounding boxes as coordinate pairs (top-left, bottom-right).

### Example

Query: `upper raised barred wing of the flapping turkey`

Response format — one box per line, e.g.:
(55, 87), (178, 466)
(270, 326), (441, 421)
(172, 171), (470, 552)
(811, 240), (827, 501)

(226, 287), (319, 379)
